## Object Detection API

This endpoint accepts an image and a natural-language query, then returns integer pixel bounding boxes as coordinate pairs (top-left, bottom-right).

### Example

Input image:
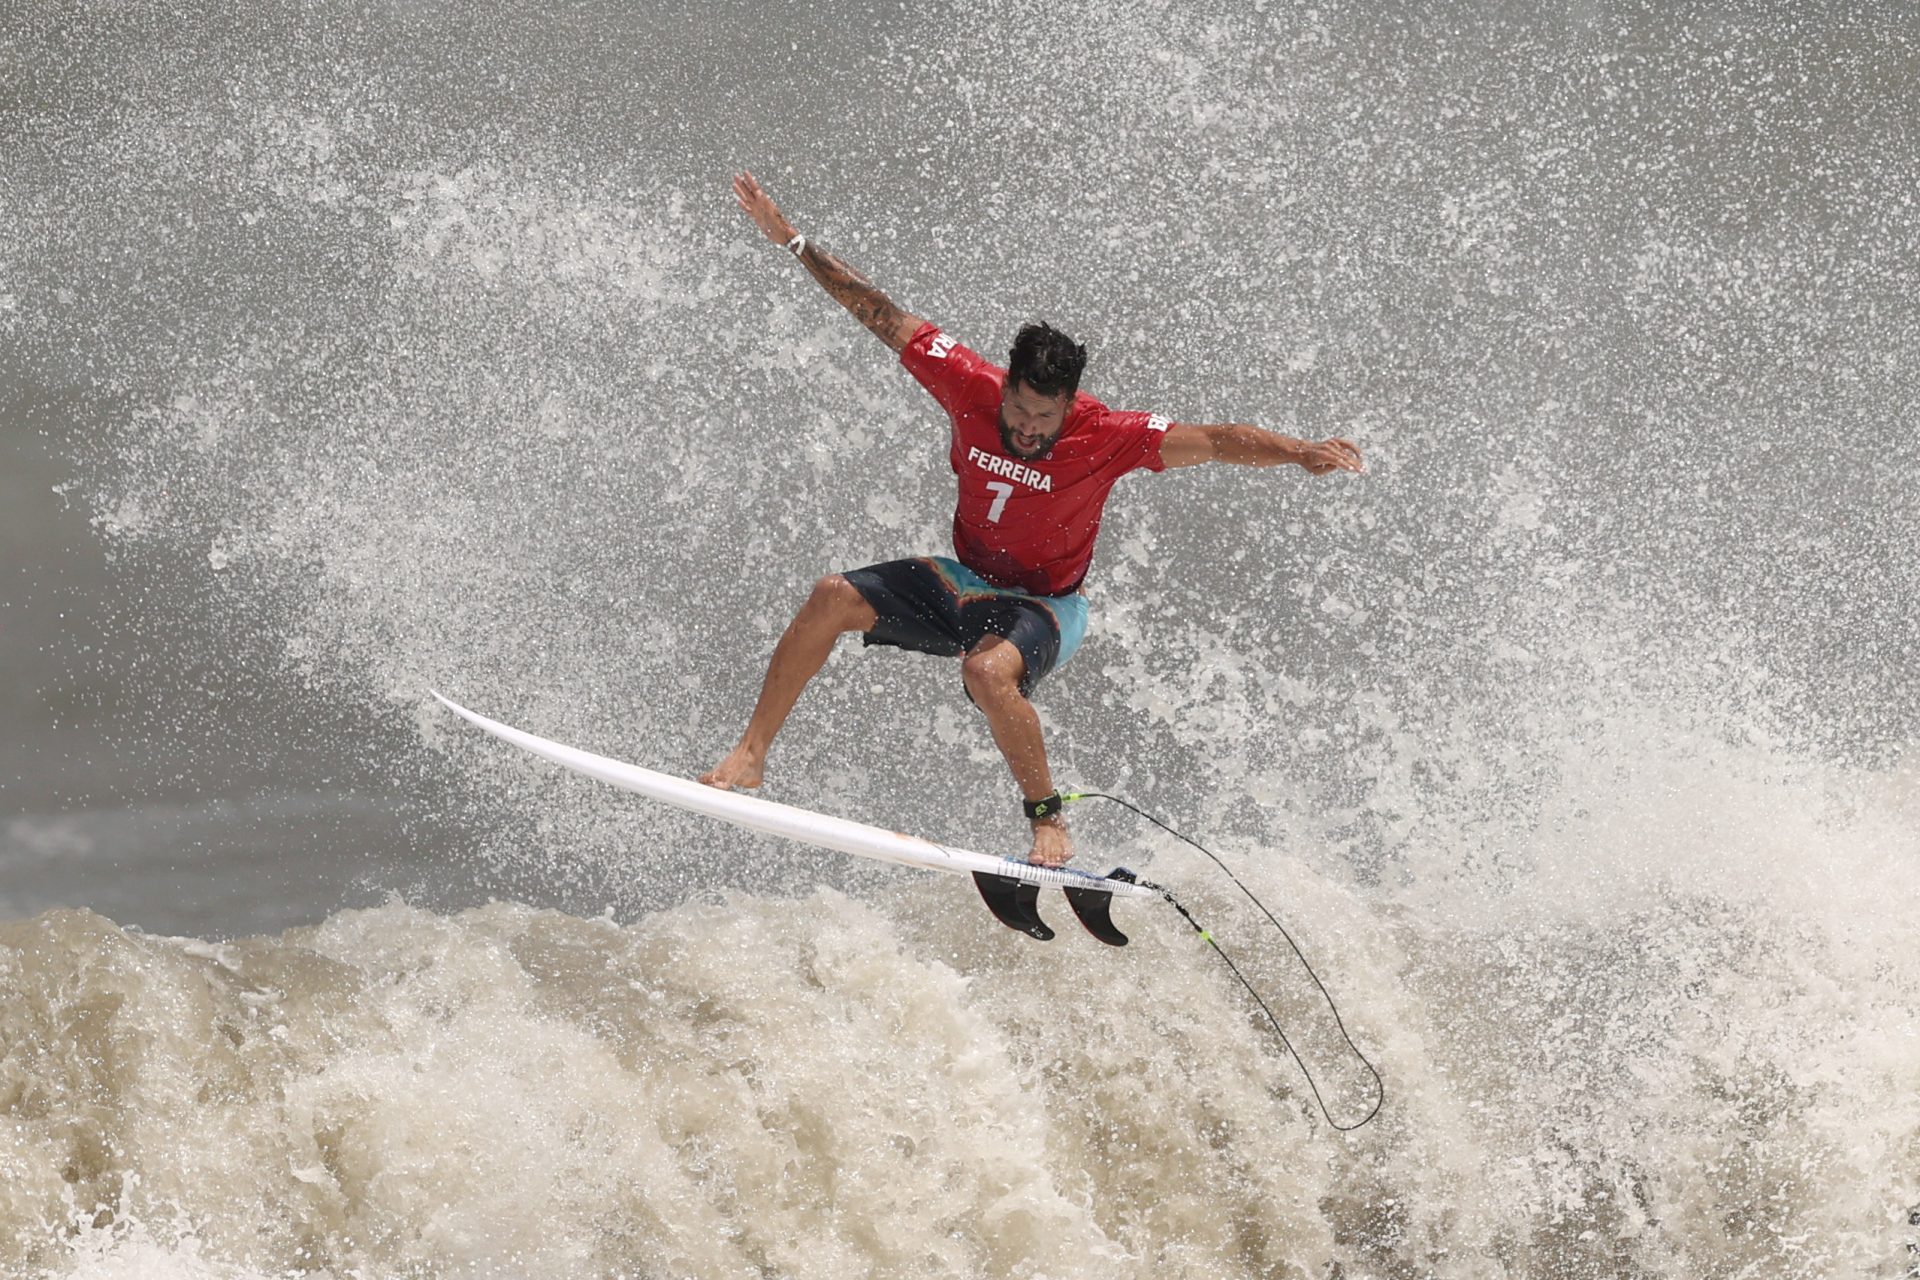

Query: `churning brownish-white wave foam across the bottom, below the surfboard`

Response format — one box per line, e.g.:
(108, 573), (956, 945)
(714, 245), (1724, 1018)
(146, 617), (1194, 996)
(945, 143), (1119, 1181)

(0, 725), (1920, 1278)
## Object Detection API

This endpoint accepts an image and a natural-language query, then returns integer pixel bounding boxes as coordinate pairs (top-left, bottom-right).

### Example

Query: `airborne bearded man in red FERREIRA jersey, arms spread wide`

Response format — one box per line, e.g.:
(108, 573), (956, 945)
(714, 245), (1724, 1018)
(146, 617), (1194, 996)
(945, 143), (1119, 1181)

(701, 173), (1361, 867)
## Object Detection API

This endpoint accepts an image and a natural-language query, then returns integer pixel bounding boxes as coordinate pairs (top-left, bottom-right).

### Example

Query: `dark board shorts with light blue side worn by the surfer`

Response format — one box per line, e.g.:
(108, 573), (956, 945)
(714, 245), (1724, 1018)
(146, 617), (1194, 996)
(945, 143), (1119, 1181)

(841, 557), (1087, 697)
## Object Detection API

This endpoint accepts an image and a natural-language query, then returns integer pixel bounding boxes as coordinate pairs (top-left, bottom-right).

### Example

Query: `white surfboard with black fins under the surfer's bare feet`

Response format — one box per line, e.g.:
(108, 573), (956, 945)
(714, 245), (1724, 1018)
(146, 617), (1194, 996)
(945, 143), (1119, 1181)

(428, 689), (1158, 946)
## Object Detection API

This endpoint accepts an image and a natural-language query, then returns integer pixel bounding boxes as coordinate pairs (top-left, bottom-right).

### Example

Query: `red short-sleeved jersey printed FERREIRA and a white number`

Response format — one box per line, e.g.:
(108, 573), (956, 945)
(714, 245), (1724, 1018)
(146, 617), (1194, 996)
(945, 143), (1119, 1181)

(900, 324), (1167, 595)
